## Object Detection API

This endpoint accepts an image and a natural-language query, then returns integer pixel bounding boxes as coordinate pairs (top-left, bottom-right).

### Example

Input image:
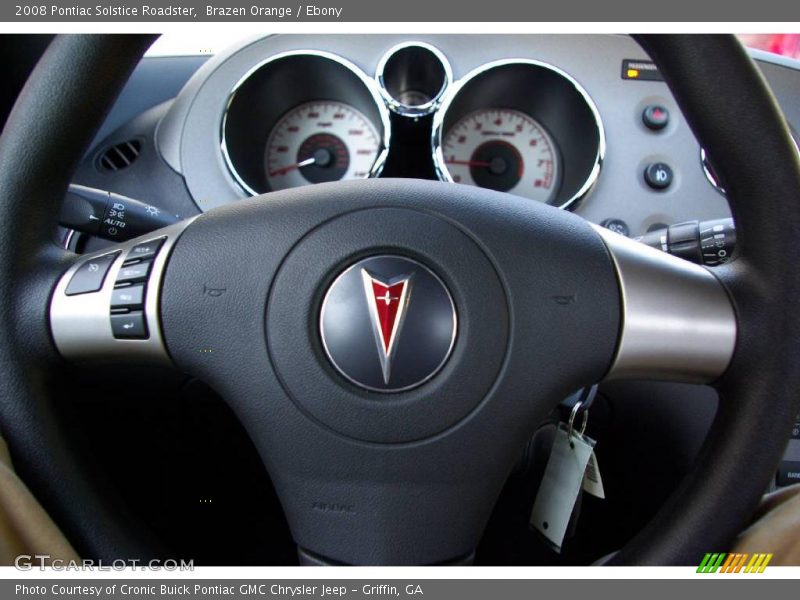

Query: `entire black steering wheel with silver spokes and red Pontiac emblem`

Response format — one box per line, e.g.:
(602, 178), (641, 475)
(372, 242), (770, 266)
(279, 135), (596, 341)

(0, 35), (800, 564)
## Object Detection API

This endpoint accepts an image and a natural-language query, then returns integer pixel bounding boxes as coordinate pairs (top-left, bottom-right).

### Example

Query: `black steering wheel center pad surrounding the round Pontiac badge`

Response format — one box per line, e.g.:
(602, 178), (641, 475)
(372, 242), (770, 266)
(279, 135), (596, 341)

(161, 180), (621, 564)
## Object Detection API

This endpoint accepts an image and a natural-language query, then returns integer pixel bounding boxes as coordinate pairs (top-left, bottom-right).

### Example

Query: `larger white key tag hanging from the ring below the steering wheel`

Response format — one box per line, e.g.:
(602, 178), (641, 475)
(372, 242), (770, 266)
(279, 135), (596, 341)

(530, 423), (595, 552)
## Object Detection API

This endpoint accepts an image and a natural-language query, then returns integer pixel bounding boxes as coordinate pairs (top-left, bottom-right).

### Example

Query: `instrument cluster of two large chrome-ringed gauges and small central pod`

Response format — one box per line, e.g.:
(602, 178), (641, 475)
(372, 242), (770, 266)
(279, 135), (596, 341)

(221, 42), (605, 208)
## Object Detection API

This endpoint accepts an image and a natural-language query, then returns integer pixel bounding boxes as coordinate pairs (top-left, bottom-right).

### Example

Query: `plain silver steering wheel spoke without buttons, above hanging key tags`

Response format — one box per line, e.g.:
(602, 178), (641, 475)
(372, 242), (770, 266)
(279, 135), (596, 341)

(593, 225), (737, 383)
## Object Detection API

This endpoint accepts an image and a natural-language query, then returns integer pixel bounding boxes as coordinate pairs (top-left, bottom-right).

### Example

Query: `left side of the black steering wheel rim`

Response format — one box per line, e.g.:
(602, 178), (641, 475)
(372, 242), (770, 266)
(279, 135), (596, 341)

(0, 35), (158, 559)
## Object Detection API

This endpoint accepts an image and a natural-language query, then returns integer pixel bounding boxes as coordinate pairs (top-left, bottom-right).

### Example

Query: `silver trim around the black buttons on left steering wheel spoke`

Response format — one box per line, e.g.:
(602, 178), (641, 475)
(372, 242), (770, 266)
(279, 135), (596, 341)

(50, 217), (196, 365)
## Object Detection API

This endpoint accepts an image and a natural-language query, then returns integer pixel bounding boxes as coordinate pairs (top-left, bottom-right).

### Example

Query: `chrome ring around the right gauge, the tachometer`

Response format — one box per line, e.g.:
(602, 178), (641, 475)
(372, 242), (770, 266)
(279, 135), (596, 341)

(431, 58), (606, 210)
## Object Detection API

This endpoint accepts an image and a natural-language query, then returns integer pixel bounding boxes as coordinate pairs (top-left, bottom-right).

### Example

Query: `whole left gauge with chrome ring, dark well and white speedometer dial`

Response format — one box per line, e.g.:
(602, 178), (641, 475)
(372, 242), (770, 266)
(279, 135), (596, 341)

(222, 51), (390, 195)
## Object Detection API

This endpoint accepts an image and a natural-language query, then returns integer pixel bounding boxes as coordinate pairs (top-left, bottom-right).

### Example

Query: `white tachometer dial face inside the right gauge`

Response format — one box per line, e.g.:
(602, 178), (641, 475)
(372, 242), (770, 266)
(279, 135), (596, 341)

(442, 108), (561, 202)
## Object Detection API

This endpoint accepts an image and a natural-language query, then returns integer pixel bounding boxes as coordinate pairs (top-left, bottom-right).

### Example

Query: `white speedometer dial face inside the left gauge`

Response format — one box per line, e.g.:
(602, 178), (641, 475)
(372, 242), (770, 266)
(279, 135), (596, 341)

(264, 101), (380, 190)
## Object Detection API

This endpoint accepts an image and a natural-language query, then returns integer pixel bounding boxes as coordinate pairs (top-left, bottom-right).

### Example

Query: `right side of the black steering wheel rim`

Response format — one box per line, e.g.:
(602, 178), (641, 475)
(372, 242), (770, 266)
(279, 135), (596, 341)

(613, 35), (800, 564)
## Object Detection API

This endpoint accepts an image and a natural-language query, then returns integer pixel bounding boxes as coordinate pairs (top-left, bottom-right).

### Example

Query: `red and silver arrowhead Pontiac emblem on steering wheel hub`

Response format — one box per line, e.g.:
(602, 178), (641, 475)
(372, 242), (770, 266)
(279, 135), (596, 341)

(361, 268), (413, 385)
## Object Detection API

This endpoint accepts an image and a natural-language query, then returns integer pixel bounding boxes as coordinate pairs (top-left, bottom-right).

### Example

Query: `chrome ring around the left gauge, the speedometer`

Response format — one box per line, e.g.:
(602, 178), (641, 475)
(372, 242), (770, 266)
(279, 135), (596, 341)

(219, 50), (392, 196)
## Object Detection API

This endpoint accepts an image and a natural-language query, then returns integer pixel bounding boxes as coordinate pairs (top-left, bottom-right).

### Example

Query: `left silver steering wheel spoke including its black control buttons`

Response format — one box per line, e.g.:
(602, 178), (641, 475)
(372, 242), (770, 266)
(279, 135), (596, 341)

(50, 219), (192, 365)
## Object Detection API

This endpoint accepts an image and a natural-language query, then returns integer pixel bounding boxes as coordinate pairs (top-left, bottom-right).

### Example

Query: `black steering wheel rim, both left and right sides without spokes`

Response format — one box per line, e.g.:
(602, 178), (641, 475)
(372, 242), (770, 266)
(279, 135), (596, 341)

(0, 36), (800, 564)
